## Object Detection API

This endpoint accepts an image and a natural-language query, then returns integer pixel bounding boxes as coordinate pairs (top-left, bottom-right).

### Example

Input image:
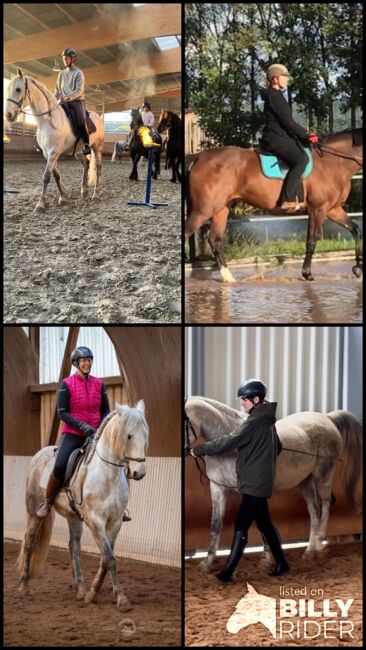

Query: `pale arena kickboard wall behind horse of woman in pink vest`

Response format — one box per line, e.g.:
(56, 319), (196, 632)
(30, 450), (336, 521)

(4, 456), (181, 567)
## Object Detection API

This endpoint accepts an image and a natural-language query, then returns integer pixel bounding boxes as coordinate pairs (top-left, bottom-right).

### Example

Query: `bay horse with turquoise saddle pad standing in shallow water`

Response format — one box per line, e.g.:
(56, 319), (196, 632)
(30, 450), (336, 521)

(185, 129), (362, 282)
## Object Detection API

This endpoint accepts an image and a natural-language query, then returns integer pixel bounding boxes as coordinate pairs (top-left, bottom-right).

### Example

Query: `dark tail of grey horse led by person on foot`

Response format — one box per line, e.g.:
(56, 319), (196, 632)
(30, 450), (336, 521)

(327, 411), (362, 512)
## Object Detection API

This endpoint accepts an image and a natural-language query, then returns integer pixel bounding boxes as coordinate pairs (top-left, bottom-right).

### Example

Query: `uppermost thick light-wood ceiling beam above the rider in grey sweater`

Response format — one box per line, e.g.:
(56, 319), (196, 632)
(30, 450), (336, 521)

(4, 3), (181, 64)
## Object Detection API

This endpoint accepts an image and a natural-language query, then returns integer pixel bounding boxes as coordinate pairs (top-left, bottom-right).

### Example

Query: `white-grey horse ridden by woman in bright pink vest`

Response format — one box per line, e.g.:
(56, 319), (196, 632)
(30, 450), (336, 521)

(17, 400), (148, 611)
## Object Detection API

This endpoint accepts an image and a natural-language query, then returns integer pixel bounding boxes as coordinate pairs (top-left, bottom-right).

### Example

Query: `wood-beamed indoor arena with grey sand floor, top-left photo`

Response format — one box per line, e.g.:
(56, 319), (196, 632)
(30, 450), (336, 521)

(4, 3), (181, 323)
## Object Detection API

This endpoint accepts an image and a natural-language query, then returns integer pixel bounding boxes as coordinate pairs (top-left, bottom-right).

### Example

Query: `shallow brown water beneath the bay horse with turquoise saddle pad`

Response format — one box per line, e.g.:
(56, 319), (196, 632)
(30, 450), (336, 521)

(185, 259), (362, 324)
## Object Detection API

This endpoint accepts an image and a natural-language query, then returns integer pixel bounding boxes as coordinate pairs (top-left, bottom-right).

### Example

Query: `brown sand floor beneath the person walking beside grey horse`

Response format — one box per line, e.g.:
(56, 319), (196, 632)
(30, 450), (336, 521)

(185, 543), (362, 647)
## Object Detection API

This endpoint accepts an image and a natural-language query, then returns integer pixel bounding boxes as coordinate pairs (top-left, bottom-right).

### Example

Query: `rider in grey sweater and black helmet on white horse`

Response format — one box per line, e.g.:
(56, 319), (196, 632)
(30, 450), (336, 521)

(55, 47), (91, 156)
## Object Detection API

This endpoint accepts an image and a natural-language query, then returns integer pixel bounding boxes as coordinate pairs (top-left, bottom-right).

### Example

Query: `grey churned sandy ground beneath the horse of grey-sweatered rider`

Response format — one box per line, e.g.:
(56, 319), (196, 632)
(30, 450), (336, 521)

(4, 159), (181, 323)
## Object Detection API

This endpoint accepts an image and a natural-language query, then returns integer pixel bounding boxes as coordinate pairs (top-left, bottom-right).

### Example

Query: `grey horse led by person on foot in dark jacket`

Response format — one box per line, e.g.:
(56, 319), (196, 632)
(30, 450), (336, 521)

(185, 396), (362, 571)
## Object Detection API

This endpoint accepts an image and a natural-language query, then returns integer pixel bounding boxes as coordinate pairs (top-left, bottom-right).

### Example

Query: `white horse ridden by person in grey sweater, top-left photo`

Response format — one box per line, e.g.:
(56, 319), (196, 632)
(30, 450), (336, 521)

(5, 68), (104, 212)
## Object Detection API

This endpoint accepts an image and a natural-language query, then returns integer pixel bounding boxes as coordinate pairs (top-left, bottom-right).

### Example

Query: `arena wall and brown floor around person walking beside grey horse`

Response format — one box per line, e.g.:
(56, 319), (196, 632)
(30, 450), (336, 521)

(185, 327), (363, 647)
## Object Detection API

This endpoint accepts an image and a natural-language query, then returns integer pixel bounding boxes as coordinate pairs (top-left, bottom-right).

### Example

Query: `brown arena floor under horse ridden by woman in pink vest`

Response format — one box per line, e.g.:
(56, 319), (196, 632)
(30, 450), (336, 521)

(4, 543), (181, 648)
